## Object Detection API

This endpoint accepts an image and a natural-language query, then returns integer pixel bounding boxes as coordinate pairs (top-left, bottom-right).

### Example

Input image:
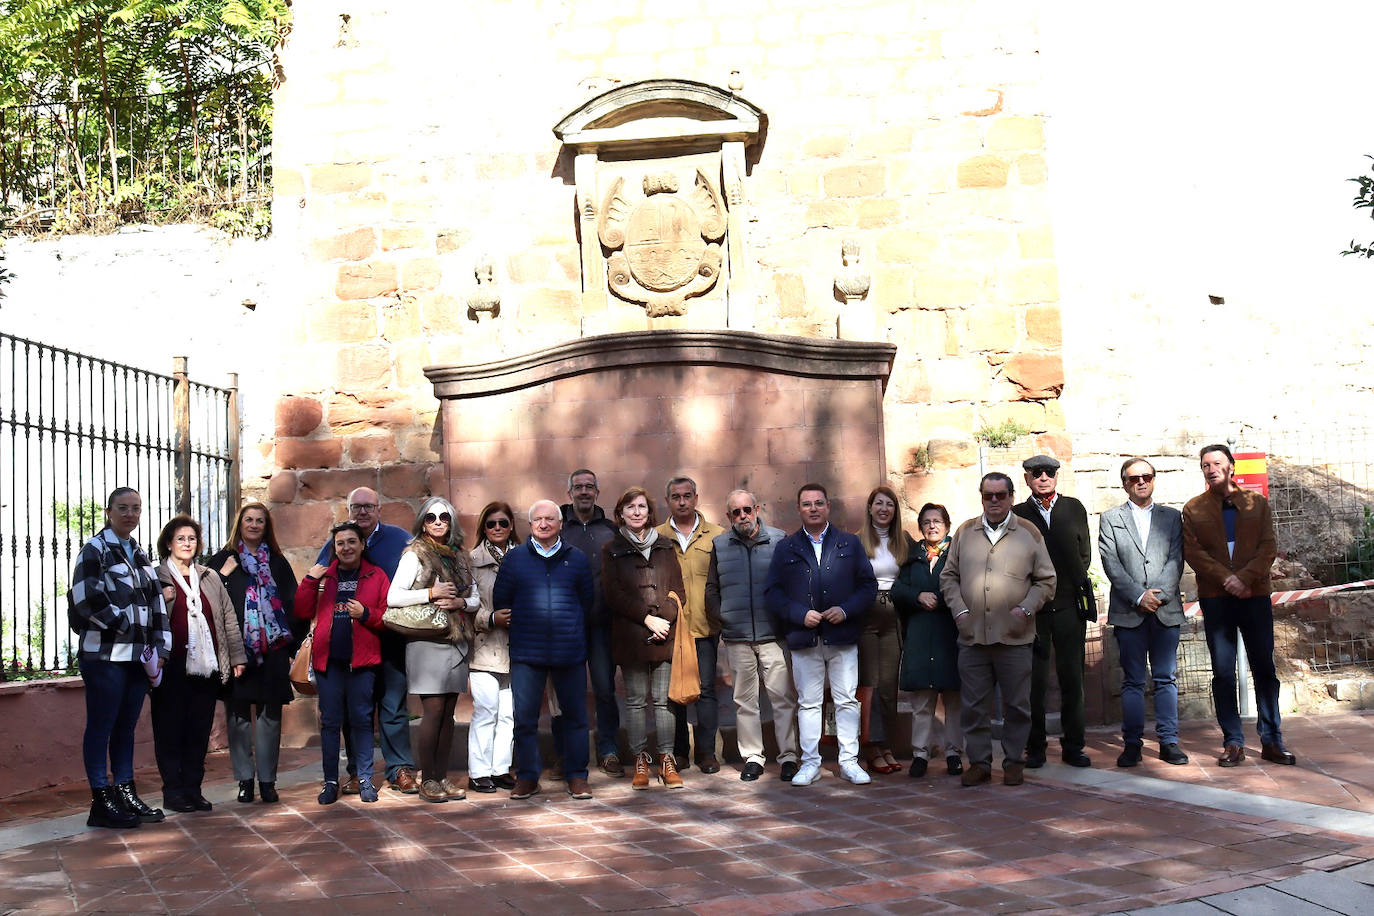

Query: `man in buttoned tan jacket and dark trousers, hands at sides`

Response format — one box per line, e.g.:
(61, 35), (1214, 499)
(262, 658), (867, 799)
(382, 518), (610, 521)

(940, 471), (1055, 786)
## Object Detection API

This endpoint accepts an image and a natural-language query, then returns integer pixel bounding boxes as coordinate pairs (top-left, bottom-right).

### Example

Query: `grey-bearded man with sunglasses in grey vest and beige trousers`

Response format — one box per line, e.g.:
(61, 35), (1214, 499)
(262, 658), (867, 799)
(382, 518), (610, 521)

(706, 490), (798, 783)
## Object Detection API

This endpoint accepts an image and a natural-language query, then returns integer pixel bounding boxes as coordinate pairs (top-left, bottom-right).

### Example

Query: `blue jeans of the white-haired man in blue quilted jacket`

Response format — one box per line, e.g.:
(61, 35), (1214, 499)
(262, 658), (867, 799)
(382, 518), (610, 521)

(511, 661), (587, 781)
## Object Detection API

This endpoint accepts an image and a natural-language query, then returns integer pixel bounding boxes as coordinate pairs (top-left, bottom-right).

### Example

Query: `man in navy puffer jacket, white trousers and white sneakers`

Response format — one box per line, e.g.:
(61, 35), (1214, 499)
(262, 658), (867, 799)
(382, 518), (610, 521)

(764, 483), (878, 786)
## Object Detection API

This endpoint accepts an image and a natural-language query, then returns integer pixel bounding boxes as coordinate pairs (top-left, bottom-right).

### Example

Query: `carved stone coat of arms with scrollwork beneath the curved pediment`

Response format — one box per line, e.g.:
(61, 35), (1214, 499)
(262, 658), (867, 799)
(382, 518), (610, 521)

(596, 169), (725, 317)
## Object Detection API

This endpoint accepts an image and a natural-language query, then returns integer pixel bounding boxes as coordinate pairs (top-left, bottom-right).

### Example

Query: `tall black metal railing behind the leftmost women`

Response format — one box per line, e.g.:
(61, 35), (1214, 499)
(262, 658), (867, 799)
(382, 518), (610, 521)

(0, 332), (239, 677)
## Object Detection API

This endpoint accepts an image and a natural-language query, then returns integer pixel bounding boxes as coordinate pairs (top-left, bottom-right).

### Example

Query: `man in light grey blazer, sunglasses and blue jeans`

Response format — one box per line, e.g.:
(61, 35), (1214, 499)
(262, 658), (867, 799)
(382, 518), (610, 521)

(1098, 457), (1189, 766)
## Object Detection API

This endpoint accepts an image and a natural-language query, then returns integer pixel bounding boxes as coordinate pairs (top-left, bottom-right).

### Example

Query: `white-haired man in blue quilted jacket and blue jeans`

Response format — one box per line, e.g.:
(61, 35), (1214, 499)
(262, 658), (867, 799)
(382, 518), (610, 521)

(492, 500), (596, 798)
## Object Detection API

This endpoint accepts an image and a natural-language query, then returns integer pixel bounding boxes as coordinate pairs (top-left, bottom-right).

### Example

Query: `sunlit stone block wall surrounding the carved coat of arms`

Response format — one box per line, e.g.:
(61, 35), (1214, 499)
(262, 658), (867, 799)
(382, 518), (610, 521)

(261, 0), (1070, 559)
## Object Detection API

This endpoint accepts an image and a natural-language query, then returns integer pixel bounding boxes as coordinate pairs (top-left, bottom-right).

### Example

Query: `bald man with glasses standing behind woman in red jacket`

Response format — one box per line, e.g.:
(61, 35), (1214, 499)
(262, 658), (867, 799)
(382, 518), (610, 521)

(315, 486), (420, 795)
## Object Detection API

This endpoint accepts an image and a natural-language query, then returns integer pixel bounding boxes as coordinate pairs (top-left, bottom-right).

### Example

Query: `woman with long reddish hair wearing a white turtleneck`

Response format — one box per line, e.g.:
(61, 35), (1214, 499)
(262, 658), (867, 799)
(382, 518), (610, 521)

(859, 486), (914, 773)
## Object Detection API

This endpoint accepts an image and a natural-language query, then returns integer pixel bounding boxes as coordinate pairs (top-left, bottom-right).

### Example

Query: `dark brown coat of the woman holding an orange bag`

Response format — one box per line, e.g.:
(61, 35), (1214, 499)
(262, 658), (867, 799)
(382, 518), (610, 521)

(602, 531), (686, 665)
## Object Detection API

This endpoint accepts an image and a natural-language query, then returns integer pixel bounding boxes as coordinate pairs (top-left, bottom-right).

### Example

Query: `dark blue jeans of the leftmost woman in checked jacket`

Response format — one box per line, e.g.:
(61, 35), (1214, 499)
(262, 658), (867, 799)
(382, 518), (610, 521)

(80, 658), (148, 788)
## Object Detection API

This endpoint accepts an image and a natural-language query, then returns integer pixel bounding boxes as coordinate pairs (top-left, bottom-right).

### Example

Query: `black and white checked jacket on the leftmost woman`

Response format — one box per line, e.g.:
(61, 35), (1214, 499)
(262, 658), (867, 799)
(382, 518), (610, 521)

(67, 529), (172, 662)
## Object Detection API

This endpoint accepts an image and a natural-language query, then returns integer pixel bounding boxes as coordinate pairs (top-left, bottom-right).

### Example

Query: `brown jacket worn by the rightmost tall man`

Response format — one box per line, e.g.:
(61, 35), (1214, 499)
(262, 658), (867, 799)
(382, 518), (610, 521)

(1183, 488), (1278, 597)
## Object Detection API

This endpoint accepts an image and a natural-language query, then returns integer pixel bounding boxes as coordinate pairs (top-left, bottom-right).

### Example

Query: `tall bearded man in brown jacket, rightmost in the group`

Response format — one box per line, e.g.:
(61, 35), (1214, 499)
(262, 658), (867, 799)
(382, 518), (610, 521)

(1183, 445), (1296, 766)
